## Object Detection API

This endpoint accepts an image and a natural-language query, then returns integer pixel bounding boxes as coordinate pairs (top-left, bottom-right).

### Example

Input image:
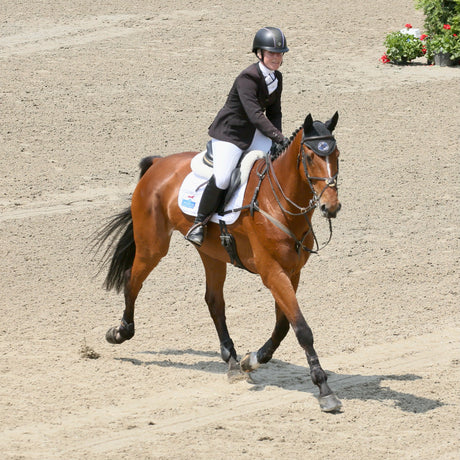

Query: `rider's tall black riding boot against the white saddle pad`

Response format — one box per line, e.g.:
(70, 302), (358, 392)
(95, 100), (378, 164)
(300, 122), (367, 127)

(185, 176), (226, 246)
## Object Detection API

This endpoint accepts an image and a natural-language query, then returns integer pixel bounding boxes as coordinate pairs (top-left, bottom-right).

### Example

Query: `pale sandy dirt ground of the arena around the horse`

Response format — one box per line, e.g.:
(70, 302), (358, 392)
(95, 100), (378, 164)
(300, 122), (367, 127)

(0, 0), (460, 460)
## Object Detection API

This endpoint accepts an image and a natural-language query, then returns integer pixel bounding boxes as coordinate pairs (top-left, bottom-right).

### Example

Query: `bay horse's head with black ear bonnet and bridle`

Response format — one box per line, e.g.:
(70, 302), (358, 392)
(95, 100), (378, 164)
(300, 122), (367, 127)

(299, 112), (342, 218)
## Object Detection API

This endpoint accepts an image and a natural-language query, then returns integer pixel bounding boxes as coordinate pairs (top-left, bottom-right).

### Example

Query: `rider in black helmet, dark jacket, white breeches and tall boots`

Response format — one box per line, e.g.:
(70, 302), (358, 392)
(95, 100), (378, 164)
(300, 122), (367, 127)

(185, 27), (289, 246)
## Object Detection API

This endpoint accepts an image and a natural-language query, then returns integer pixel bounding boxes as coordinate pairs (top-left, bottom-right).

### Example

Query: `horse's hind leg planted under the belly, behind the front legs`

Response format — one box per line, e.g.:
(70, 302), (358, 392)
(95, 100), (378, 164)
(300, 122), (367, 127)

(200, 252), (245, 381)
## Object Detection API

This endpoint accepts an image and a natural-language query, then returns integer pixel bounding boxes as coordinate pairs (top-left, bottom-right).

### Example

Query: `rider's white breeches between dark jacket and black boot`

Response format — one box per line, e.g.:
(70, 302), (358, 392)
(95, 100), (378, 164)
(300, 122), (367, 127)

(211, 129), (272, 190)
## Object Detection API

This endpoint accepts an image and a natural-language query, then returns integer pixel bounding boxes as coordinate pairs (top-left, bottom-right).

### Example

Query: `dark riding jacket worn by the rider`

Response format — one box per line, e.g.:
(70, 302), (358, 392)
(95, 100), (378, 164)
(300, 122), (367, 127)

(208, 63), (284, 150)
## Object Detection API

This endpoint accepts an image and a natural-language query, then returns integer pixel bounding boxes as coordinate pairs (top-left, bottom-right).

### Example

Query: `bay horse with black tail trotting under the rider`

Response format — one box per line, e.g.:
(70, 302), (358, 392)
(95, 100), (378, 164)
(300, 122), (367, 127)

(96, 112), (342, 412)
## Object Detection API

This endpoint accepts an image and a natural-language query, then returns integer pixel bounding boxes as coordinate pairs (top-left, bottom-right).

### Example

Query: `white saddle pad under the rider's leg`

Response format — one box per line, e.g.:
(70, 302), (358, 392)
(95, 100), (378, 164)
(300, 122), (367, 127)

(178, 150), (264, 225)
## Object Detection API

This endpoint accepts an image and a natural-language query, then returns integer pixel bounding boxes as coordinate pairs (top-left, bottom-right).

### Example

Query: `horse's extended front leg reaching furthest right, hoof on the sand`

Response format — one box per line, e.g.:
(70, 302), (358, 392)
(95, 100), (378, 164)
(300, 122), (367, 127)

(262, 266), (342, 412)
